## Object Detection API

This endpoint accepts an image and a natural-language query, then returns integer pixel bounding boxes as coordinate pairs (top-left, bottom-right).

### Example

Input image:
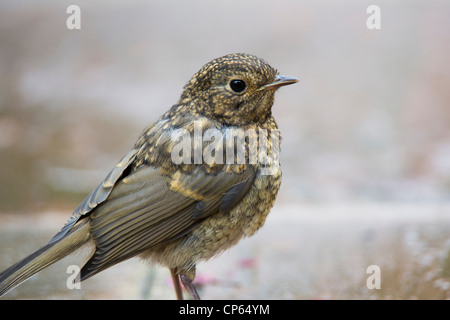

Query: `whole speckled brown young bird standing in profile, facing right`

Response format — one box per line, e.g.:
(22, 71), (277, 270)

(0, 54), (298, 298)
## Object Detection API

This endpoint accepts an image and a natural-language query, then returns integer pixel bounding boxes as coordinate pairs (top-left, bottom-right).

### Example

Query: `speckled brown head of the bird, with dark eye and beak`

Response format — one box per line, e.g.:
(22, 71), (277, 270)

(180, 53), (298, 125)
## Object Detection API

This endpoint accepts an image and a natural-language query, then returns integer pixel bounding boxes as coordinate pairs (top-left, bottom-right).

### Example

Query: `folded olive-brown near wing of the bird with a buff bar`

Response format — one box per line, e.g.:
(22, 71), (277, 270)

(81, 162), (256, 280)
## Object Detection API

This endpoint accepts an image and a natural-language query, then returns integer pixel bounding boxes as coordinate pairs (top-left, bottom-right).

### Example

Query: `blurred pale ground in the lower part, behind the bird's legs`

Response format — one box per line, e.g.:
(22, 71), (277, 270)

(0, 203), (450, 299)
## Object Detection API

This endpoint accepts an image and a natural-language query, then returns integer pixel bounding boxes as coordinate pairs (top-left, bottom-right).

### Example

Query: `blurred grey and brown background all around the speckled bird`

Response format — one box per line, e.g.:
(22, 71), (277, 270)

(0, 0), (450, 299)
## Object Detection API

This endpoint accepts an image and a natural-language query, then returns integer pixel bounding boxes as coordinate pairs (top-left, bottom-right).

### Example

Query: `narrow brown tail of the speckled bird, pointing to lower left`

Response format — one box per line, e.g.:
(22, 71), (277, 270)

(0, 219), (89, 296)
